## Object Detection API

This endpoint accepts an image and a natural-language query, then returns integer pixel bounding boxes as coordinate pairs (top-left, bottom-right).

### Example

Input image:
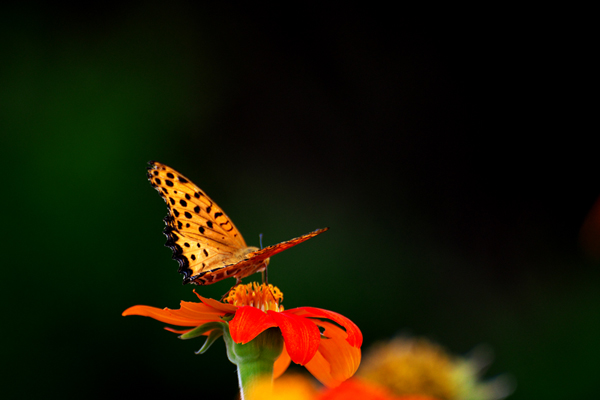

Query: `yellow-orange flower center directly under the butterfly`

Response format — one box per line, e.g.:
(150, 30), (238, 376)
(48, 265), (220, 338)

(223, 282), (283, 312)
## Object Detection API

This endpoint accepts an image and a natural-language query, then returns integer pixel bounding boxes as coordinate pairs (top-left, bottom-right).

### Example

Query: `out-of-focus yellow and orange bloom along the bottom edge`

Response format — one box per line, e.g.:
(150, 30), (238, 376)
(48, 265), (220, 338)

(247, 338), (512, 400)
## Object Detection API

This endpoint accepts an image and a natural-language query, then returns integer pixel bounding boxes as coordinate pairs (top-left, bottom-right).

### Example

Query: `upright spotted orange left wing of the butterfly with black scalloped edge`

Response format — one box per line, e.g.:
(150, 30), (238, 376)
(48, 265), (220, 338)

(148, 161), (248, 283)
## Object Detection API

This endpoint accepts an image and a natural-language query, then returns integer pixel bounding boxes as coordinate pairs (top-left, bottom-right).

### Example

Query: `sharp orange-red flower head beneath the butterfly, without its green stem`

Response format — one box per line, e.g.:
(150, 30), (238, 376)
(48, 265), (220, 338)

(123, 283), (362, 387)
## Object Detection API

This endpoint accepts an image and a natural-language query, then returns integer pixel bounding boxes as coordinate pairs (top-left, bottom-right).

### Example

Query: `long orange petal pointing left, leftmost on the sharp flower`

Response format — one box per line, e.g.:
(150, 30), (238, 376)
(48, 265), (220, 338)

(122, 301), (224, 326)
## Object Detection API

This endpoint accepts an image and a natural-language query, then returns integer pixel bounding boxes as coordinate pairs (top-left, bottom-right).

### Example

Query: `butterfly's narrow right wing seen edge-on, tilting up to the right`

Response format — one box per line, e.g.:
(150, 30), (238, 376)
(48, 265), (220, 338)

(190, 228), (329, 285)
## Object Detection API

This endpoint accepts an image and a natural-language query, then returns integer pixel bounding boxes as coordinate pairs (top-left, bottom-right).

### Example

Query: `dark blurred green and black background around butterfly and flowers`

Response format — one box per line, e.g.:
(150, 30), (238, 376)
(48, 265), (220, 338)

(0, 2), (600, 400)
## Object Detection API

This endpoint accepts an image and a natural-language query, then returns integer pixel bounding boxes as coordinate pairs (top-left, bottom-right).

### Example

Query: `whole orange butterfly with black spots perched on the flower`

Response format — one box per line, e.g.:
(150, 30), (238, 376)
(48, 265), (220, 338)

(147, 161), (329, 285)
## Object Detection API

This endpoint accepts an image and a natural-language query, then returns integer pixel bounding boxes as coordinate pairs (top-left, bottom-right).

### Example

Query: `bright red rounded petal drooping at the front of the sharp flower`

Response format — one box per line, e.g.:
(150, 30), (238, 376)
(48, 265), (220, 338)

(267, 310), (321, 365)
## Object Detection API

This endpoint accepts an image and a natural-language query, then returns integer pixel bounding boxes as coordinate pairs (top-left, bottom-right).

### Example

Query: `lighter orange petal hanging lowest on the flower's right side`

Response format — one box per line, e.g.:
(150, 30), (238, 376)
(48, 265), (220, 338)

(306, 321), (361, 387)
